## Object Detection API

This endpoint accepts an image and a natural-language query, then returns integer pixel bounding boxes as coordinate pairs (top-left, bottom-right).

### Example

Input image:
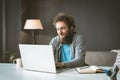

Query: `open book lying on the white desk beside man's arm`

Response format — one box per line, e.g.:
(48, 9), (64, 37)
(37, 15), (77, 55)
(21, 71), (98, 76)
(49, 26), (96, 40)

(75, 65), (104, 74)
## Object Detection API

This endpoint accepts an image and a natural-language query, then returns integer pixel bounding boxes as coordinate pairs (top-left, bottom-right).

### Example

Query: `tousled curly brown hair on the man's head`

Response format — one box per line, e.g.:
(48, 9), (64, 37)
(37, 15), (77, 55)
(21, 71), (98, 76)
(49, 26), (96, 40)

(53, 13), (75, 29)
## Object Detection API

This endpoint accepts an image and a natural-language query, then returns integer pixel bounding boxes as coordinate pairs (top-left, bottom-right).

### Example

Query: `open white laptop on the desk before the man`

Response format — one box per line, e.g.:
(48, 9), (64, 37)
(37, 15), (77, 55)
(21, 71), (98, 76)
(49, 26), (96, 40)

(19, 44), (68, 73)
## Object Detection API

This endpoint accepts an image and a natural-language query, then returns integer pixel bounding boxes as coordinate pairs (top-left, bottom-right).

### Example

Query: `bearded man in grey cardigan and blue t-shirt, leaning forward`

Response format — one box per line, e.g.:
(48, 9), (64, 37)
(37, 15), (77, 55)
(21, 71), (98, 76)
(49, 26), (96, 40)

(50, 13), (86, 67)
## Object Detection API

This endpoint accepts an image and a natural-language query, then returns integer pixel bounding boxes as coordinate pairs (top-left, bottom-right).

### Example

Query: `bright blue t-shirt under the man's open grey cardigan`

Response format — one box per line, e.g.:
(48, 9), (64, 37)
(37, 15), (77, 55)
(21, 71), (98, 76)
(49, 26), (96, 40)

(61, 44), (72, 62)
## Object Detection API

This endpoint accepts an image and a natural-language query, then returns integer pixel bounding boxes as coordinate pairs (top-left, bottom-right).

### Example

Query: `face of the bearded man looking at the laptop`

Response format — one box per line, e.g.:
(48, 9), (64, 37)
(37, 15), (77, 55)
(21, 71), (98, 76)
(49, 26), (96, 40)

(56, 21), (72, 41)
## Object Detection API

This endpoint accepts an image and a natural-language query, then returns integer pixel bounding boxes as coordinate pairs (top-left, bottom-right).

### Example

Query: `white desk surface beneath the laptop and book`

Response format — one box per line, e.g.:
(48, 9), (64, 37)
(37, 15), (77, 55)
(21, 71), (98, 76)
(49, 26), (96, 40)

(0, 63), (109, 80)
